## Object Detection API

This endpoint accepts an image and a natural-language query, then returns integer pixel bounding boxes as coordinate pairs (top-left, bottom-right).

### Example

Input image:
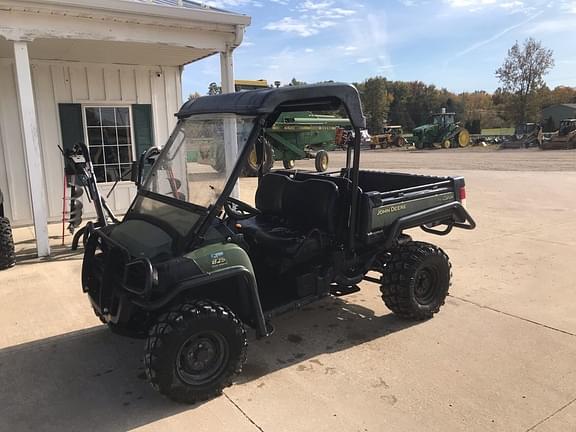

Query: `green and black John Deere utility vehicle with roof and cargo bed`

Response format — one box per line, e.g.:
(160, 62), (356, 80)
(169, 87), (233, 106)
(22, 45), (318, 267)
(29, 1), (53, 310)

(82, 84), (475, 403)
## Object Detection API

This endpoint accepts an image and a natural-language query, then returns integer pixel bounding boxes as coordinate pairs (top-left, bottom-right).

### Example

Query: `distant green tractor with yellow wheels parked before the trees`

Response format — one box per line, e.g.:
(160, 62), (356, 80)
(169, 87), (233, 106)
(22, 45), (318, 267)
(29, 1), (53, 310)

(412, 108), (470, 149)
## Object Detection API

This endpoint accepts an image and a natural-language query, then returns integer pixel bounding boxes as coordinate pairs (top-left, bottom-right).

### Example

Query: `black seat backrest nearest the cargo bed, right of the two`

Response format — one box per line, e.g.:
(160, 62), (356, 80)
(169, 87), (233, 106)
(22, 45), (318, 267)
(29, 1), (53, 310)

(282, 179), (338, 234)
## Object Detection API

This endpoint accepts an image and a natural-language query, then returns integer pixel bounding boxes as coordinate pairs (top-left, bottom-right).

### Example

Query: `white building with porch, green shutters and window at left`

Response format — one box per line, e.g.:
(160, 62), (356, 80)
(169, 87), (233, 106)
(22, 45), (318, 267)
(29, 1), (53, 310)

(0, 0), (250, 256)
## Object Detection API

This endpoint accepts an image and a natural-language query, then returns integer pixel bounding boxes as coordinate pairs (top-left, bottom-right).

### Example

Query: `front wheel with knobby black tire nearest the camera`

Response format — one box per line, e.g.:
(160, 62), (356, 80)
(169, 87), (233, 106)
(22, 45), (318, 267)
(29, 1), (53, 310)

(144, 300), (248, 404)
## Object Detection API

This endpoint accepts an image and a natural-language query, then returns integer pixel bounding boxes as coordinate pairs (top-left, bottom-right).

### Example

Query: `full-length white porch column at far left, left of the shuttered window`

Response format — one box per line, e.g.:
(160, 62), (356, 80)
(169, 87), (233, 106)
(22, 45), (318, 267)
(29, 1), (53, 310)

(14, 41), (50, 257)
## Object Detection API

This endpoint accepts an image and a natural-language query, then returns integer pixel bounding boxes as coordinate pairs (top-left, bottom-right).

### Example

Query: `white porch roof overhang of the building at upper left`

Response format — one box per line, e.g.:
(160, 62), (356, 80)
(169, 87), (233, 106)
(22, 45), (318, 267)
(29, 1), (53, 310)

(0, 0), (250, 65)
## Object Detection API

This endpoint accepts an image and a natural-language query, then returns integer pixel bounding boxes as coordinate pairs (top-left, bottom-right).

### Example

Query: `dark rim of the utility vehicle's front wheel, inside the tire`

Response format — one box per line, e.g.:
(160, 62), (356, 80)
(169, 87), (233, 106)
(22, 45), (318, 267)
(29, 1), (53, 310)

(176, 331), (230, 386)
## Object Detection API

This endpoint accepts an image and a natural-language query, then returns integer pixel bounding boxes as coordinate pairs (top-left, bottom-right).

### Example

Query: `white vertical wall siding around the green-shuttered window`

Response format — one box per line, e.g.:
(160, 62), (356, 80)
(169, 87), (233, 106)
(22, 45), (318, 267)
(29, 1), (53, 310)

(0, 59), (182, 226)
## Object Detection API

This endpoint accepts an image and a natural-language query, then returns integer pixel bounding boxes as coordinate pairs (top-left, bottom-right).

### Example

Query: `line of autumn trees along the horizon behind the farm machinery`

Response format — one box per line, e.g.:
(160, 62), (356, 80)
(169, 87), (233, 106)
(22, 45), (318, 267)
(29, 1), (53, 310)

(196, 38), (576, 134)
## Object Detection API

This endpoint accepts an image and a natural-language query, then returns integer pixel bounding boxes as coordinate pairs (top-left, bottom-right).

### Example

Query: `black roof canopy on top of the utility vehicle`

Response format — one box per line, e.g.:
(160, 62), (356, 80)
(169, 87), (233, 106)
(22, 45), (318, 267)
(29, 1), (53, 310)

(176, 83), (366, 128)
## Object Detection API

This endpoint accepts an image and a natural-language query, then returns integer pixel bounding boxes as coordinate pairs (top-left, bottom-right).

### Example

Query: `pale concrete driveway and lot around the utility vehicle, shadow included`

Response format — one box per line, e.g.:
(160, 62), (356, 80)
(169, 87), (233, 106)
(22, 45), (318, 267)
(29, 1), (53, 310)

(0, 150), (576, 432)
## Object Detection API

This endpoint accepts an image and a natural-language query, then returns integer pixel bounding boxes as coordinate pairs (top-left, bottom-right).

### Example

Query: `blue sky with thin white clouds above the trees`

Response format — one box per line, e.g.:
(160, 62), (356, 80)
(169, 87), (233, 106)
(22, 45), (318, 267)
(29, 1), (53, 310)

(183, 0), (576, 96)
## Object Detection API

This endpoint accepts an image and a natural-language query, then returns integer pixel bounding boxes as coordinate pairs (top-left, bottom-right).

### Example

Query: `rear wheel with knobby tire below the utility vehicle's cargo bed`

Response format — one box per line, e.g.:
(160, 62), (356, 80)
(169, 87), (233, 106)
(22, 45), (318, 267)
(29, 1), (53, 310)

(380, 242), (452, 321)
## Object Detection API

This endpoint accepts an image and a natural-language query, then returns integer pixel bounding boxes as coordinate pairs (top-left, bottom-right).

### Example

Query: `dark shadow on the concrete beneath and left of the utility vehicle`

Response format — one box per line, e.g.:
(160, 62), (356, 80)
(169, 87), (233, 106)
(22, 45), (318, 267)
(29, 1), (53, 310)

(0, 292), (412, 432)
